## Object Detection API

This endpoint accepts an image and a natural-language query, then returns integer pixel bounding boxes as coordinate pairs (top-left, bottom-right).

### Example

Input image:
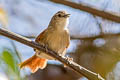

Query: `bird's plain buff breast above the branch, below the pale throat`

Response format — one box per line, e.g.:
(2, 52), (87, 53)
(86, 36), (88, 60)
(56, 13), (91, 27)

(47, 31), (67, 54)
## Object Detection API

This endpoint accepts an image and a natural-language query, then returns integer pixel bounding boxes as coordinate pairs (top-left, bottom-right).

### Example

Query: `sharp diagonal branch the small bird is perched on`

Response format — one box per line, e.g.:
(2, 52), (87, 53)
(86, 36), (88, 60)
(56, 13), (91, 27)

(0, 28), (104, 80)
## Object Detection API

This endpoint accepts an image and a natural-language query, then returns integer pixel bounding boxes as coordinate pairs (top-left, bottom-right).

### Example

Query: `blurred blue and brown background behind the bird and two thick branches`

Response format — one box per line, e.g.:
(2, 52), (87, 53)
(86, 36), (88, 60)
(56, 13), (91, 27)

(0, 0), (120, 80)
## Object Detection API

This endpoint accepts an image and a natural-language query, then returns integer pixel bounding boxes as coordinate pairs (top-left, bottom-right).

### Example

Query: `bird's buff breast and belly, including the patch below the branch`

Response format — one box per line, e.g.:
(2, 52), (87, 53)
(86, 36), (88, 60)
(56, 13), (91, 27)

(36, 31), (68, 59)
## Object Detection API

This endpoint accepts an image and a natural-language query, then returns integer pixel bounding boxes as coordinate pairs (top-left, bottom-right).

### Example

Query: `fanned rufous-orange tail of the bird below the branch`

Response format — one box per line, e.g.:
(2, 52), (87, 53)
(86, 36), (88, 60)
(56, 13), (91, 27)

(19, 55), (47, 73)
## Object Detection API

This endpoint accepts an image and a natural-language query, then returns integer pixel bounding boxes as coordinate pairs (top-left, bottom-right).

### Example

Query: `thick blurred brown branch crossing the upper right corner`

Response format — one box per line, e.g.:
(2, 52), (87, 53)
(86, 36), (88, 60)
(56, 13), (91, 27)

(50, 0), (120, 23)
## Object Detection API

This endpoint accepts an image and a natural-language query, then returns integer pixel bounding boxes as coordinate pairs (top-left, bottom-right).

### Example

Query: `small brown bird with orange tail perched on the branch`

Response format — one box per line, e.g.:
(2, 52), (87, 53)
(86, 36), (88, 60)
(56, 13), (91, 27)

(19, 11), (70, 73)
